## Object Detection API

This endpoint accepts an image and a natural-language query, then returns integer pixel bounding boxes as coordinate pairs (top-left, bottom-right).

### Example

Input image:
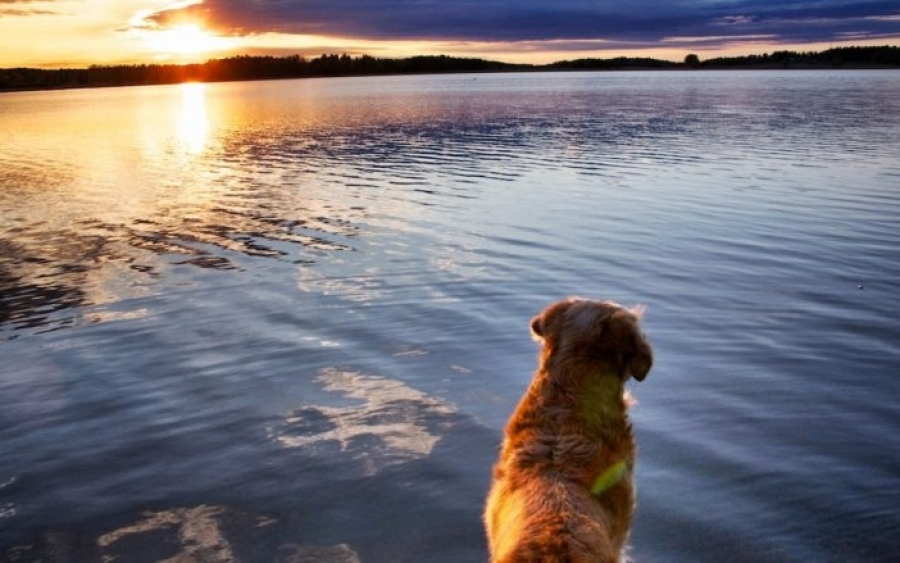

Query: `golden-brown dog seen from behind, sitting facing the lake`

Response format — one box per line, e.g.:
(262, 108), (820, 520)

(484, 298), (653, 563)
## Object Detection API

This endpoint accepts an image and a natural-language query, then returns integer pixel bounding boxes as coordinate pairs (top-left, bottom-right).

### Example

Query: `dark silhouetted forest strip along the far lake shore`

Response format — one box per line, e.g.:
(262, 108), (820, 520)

(0, 46), (900, 91)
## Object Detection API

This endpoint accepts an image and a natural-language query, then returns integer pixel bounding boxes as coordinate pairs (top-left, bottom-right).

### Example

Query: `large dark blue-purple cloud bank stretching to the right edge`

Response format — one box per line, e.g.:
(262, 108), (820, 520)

(144, 0), (900, 46)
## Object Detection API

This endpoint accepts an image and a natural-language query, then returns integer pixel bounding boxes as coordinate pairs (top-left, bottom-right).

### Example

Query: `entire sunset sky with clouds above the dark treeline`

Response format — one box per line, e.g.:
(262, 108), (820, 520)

(0, 0), (900, 68)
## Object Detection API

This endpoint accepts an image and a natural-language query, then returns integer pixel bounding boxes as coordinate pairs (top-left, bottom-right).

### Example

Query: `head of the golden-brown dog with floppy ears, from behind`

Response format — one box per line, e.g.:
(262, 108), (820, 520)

(531, 298), (653, 381)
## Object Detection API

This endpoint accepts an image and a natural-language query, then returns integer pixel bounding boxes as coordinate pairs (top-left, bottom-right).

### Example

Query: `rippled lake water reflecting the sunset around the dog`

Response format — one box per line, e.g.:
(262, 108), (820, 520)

(0, 71), (900, 562)
